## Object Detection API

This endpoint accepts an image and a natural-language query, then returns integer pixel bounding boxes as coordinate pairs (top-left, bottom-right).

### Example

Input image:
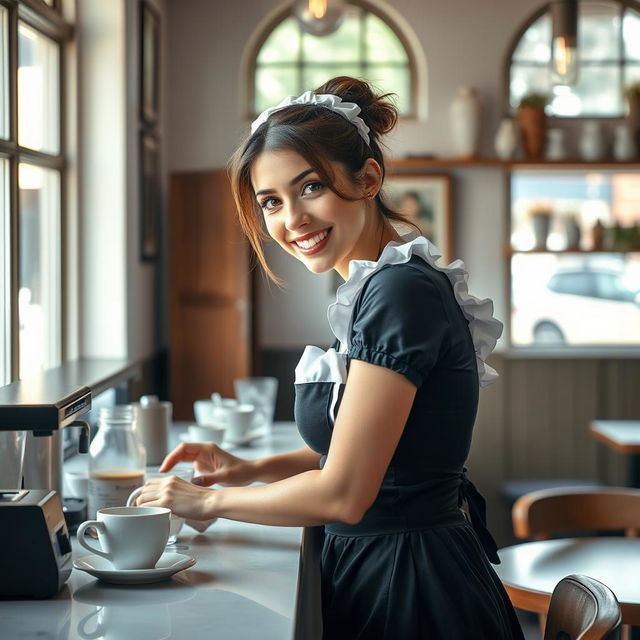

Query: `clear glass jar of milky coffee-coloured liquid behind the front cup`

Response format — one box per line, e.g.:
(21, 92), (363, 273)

(89, 405), (146, 518)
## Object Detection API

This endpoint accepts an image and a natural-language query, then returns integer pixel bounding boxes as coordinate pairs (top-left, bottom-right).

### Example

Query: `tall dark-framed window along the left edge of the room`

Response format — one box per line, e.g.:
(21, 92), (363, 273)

(0, 0), (70, 384)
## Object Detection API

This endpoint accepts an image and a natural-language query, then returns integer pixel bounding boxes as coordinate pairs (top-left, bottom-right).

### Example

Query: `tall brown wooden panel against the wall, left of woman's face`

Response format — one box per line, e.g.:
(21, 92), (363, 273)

(169, 169), (252, 420)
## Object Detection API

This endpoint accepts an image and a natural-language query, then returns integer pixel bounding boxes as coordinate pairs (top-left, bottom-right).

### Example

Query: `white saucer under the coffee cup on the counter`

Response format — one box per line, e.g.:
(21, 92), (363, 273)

(73, 552), (196, 584)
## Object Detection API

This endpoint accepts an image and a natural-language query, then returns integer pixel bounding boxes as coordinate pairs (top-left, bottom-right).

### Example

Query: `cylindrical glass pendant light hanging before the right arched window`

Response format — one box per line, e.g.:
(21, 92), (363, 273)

(550, 0), (578, 86)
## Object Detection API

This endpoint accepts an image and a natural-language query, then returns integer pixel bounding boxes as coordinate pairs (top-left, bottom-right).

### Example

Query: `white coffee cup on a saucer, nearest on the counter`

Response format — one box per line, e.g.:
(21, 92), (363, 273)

(77, 507), (171, 570)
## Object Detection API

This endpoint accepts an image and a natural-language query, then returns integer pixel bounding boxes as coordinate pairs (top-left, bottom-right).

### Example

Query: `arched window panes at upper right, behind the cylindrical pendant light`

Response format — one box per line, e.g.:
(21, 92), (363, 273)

(508, 0), (640, 117)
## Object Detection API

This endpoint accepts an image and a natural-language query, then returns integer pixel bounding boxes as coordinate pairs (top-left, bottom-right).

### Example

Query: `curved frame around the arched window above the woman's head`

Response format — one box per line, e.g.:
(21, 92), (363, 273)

(244, 0), (420, 120)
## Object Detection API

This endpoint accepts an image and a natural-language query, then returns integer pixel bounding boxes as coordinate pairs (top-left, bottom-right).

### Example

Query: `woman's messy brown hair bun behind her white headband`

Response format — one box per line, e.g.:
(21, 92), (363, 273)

(314, 76), (398, 138)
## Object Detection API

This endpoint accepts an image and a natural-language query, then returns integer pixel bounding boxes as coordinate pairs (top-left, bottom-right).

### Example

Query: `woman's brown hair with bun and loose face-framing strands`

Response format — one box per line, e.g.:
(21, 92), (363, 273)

(230, 76), (415, 282)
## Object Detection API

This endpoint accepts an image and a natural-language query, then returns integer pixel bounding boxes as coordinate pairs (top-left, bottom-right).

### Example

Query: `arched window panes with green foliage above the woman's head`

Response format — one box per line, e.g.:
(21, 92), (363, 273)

(249, 3), (417, 116)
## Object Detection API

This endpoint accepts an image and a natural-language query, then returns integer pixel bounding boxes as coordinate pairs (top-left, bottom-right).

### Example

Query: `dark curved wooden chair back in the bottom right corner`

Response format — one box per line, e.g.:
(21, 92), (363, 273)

(544, 575), (622, 640)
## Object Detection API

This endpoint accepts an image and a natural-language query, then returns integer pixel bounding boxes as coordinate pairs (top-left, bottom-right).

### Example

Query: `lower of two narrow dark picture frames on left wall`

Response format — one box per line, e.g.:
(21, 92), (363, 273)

(140, 133), (162, 261)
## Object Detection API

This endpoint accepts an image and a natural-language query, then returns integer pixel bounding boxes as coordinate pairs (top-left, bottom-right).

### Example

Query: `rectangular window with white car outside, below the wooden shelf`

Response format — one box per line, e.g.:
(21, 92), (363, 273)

(510, 169), (640, 348)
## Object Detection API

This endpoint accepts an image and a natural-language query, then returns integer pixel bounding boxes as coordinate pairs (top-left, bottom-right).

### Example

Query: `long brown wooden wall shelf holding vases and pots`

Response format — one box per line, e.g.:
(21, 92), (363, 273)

(389, 156), (640, 173)
